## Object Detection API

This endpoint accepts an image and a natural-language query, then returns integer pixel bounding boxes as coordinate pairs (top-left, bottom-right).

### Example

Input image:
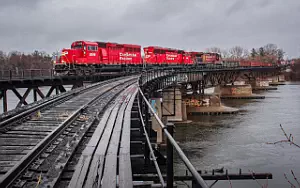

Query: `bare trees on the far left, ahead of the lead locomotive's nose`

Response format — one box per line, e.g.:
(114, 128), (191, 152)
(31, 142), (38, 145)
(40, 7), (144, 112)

(0, 50), (53, 70)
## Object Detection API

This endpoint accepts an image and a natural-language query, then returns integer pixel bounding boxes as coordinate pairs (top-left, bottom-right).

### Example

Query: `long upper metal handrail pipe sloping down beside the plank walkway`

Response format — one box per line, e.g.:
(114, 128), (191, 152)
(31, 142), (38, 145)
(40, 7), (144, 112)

(139, 87), (208, 188)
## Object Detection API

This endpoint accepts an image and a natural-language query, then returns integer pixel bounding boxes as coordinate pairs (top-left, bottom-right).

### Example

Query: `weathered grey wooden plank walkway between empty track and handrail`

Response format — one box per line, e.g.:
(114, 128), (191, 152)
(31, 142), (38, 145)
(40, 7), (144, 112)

(69, 85), (137, 188)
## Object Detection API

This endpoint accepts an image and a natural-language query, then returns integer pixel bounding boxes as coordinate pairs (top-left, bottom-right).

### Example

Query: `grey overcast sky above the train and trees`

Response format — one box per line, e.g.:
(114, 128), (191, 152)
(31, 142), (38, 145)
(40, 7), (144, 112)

(0, 0), (300, 57)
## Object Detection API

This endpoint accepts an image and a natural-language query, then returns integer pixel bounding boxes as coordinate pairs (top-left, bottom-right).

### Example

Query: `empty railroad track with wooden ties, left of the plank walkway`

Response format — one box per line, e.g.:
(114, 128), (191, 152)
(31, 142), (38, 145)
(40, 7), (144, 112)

(0, 77), (136, 187)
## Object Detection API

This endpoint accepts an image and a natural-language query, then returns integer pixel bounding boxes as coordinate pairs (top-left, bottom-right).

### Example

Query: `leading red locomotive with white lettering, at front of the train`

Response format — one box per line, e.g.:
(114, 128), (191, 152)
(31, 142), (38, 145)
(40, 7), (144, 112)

(55, 41), (142, 73)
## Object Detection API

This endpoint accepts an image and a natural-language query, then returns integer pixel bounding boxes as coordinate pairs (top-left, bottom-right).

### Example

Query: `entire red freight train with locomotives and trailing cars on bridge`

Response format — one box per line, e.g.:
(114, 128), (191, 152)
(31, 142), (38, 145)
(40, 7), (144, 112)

(54, 41), (272, 74)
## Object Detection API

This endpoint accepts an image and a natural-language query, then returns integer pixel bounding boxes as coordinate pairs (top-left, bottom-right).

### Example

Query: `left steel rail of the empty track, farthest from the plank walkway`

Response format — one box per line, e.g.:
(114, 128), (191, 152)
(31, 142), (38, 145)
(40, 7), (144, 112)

(0, 75), (132, 128)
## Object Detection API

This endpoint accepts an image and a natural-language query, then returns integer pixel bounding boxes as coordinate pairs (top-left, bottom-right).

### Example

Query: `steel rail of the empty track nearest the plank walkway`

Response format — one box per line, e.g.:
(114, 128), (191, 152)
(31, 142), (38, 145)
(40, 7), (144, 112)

(0, 78), (134, 187)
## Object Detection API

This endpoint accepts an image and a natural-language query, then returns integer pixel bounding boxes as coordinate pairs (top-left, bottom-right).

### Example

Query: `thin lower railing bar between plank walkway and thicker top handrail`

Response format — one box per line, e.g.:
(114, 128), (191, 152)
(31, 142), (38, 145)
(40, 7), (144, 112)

(138, 91), (165, 187)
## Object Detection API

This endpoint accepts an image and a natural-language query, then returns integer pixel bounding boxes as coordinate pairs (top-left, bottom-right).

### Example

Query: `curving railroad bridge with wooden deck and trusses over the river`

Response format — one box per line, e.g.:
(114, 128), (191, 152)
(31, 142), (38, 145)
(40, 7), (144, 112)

(0, 67), (283, 187)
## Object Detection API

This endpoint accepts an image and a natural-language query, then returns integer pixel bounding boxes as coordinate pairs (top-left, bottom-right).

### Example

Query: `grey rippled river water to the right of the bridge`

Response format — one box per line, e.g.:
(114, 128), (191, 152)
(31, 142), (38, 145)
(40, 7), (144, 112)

(175, 83), (300, 188)
